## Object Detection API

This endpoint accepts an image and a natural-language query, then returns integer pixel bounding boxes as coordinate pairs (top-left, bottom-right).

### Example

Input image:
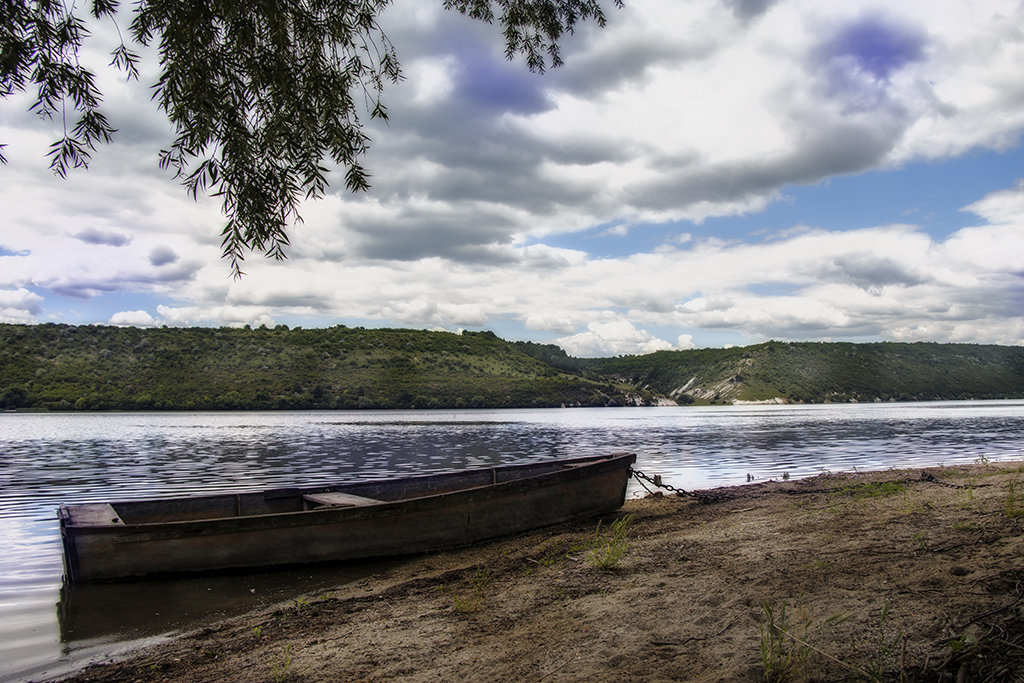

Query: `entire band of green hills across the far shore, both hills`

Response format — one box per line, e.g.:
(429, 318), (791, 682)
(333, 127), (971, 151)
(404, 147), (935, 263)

(0, 325), (1024, 410)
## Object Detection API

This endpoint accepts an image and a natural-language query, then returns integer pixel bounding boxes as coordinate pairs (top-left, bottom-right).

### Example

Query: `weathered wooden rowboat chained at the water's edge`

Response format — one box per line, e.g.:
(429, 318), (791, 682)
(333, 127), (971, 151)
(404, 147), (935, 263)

(57, 454), (635, 583)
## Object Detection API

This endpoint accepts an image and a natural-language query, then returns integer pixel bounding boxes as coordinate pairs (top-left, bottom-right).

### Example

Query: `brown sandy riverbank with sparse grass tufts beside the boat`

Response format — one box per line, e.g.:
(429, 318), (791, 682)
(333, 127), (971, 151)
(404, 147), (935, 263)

(56, 461), (1024, 683)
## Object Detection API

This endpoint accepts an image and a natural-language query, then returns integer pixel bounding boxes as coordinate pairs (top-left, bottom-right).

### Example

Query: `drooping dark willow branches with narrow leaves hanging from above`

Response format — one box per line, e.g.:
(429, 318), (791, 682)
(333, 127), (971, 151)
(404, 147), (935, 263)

(0, 0), (622, 275)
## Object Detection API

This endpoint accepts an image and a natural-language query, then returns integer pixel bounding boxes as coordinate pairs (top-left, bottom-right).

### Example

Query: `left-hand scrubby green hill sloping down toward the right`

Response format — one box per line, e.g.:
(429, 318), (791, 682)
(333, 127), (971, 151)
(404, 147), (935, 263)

(0, 325), (644, 410)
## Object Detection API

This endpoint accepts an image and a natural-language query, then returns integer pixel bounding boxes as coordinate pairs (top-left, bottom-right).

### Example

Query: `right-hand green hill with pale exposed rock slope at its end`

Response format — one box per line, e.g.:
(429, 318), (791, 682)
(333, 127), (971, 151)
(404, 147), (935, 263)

(591, 342), (1024, 402)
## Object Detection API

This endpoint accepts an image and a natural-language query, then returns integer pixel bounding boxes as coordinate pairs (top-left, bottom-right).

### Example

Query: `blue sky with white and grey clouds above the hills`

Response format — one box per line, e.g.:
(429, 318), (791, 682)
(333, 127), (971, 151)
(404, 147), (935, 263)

(0, 0), (1024, 356)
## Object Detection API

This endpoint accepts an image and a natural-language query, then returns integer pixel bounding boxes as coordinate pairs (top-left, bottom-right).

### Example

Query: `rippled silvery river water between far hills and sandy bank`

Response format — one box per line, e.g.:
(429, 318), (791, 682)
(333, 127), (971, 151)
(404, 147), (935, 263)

(0, 401), (1024, 680)
